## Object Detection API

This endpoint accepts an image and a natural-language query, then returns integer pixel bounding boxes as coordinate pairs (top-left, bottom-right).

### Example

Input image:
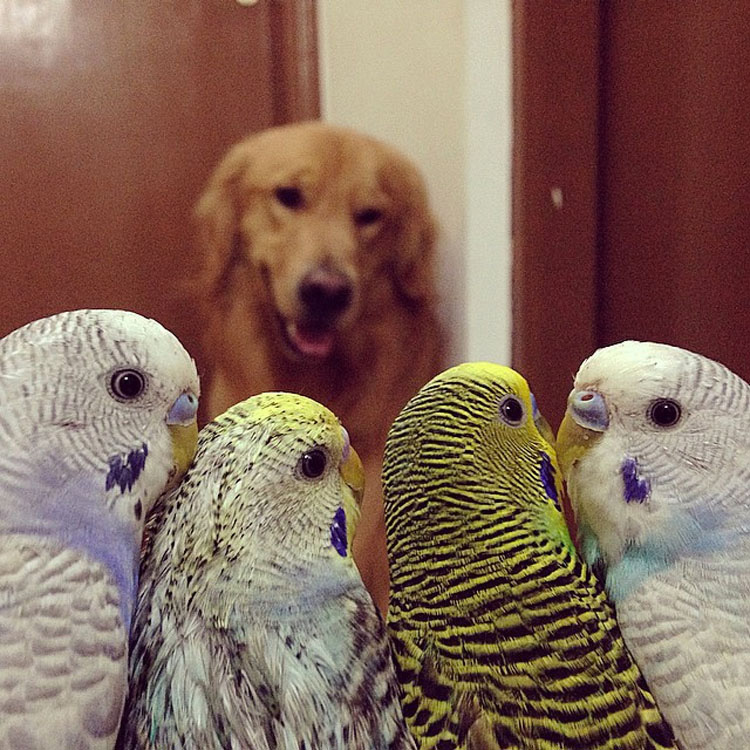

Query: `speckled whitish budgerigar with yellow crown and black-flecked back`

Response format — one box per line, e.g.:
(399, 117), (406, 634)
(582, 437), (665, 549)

(118, 393), (414, 750)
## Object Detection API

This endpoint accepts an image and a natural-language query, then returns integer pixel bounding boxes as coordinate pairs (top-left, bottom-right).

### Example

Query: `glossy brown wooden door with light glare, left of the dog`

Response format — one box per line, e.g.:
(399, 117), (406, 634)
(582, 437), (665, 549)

(0, 0), (318, 366)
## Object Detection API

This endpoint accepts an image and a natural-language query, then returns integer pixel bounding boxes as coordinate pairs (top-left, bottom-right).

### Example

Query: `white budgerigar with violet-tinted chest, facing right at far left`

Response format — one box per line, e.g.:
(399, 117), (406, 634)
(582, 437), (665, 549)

(0, 310), (199, 750)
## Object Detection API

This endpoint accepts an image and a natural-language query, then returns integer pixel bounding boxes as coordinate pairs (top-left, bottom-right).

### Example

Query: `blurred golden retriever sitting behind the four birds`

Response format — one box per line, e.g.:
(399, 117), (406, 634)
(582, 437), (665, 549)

(195, 122), (444, 610)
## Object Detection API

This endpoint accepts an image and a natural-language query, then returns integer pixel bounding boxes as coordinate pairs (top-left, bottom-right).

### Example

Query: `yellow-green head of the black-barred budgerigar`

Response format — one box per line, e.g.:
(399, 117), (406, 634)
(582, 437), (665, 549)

(383, 362), (570, 565)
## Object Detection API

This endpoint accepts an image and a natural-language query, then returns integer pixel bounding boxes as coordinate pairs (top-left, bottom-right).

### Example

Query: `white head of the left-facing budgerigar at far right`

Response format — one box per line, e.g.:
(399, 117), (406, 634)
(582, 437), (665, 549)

(557, 341), (750, 592)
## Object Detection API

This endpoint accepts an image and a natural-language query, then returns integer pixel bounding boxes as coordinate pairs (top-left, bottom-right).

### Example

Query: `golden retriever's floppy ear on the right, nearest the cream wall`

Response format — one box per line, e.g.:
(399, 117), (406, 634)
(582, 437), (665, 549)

(391, 162), (438, 304)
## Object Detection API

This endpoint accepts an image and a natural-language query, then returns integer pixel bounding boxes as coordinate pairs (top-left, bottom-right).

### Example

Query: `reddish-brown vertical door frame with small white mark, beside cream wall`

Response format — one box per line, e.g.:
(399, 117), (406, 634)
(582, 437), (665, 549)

(513, 0), (599, 427)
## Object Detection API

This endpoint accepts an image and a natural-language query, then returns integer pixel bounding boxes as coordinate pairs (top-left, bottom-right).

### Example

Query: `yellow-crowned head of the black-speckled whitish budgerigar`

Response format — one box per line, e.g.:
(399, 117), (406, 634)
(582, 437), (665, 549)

(174, 392), (364, 598)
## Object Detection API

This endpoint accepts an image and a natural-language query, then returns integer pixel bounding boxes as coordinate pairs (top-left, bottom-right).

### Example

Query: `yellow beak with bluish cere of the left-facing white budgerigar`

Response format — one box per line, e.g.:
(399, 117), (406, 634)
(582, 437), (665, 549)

(557, 390), (609, 477)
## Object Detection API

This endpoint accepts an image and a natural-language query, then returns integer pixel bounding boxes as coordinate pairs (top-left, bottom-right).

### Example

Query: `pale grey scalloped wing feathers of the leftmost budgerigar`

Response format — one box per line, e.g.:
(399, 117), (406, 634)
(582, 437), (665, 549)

(0, 539), (127, 747)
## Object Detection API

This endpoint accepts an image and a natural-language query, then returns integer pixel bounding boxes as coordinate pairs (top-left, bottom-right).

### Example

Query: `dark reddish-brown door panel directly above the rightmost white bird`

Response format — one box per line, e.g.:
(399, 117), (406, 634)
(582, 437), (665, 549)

(599, 0), (750, 379)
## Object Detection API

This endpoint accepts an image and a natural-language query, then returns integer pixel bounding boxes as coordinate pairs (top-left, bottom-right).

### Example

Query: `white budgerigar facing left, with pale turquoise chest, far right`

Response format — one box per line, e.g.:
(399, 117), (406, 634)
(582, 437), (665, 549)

(558, 341), (750, 750)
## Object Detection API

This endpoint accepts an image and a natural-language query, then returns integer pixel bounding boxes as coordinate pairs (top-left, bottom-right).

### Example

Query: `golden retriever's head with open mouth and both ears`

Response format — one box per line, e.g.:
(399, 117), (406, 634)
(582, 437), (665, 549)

(196, 122), (435, 360)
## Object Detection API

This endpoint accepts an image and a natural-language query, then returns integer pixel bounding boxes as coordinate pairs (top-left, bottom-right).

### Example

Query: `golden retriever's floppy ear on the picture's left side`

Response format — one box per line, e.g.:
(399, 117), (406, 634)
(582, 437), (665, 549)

(193, 138), (253, 299)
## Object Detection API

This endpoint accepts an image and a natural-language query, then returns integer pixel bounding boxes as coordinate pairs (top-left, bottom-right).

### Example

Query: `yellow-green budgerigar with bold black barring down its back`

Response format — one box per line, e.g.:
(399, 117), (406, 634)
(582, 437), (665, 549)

(383, 363), (674, 750)
